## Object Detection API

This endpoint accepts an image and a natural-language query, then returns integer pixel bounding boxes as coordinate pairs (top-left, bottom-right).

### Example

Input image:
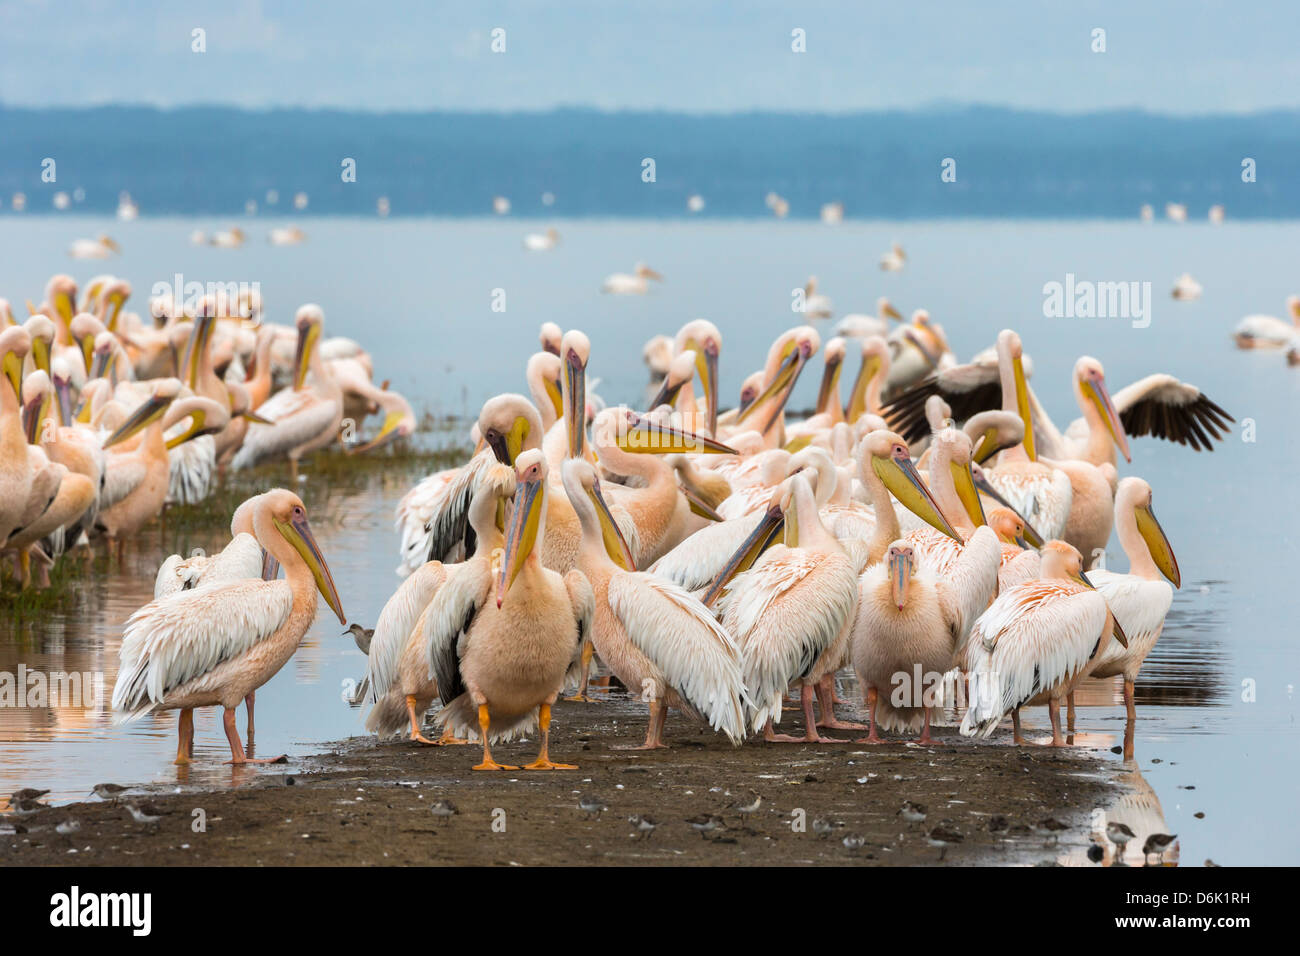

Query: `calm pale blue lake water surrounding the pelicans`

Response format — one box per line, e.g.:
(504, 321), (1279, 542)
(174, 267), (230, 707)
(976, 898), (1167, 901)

(0, 216), (1300, 865)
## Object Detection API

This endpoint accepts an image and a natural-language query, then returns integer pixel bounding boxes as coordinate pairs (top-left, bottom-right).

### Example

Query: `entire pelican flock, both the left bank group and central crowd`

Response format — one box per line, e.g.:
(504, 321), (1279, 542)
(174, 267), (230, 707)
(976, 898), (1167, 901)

(0, 260), (1227, 771)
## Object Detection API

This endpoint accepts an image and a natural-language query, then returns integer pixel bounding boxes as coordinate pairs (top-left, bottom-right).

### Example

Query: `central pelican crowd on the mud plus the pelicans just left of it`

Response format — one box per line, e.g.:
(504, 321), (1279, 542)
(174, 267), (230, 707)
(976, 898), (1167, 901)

(98, 306), (1232, 770)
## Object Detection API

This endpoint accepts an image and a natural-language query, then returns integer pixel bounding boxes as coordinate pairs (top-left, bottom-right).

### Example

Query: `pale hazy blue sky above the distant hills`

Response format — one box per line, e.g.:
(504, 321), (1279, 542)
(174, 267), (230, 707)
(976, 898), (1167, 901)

(0, 0), (1300, 113)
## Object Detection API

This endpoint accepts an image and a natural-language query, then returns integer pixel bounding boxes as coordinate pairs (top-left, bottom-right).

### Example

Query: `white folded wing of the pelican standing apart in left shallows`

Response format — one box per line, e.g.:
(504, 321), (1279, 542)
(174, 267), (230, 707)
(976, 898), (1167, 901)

(113, 579), (294, 721)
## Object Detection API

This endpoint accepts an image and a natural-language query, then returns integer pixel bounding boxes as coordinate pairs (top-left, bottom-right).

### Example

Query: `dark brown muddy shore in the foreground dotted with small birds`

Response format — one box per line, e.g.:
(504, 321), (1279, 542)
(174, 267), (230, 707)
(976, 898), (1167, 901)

(0, 696), (1123, 866)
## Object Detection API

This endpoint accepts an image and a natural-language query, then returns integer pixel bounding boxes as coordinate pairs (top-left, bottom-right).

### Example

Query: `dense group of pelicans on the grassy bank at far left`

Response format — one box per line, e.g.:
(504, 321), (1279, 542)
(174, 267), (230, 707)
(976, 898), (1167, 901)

(0, 274), (416, 588)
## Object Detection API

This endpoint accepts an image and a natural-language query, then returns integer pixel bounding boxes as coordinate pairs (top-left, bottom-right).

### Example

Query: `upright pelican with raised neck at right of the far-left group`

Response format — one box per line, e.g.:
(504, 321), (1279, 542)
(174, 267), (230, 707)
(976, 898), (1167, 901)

(230, 306), (343, 481)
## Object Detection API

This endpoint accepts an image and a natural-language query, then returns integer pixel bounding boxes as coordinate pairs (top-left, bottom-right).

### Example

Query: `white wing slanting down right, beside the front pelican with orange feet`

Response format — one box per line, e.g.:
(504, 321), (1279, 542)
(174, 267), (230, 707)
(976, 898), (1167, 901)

(610, 572), (745, 744)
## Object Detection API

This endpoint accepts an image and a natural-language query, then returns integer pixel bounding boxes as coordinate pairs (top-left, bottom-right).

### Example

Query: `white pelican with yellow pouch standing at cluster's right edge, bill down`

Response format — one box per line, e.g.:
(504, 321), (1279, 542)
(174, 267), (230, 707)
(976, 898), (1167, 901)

(1088, 477), (1183, 756)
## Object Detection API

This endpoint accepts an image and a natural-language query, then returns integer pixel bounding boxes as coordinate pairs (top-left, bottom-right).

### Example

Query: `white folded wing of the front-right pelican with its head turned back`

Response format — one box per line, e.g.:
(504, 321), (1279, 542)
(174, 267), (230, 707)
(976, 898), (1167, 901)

(961, 580), (1106, 737)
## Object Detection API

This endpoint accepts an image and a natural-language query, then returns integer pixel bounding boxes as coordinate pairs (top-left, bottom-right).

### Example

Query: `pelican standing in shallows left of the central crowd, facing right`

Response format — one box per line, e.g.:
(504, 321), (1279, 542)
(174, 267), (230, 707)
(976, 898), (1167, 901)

(113, 488), (347, 763)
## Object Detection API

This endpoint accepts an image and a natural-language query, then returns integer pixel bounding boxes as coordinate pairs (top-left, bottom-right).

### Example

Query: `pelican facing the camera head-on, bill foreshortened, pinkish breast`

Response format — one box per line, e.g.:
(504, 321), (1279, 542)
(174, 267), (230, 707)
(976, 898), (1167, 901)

(850, 528), (1001, 744)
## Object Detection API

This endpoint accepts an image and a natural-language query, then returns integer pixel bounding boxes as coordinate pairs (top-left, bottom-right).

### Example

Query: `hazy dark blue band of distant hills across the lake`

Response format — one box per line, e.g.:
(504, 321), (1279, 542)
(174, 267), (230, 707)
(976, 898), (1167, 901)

(0, 107), (1300, 219)
